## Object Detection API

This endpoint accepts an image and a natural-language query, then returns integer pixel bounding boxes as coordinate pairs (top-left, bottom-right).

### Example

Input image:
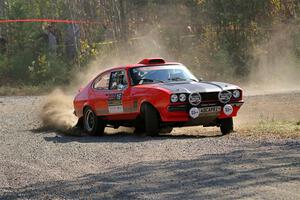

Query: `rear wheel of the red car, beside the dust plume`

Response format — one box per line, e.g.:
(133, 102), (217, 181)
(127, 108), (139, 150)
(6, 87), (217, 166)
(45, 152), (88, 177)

(83, 108), (106, 135)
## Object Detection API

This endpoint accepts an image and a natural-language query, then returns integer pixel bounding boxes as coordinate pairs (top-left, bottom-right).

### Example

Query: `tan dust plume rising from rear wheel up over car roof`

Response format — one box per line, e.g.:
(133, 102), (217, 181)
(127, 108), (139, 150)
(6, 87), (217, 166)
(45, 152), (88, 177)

(41, 31), (169, 134)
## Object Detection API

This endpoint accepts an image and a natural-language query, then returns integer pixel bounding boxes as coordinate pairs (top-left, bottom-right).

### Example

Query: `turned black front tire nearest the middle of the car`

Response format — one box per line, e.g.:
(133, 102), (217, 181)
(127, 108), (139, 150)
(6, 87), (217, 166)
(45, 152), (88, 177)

(143, 104), (159, 136)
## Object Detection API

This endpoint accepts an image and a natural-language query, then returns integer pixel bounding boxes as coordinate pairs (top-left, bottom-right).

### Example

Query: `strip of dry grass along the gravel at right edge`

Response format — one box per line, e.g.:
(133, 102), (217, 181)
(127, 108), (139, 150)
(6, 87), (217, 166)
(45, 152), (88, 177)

(238, 121), (300, 139)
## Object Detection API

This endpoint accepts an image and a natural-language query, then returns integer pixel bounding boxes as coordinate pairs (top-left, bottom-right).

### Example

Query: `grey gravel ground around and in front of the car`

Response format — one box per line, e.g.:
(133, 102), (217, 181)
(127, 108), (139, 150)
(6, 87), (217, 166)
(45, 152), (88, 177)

(0, 92), (300, 199)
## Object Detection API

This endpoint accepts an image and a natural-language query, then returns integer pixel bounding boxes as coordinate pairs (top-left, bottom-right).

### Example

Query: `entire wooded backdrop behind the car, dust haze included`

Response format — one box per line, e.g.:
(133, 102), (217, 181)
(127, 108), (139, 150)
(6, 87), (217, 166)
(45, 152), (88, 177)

(0, 0), (300, 94)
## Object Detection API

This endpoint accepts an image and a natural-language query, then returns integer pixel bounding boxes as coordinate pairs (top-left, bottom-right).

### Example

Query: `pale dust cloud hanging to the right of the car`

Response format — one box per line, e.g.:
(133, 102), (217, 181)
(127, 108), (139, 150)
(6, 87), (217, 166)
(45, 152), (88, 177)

(244, 24), (300, 95)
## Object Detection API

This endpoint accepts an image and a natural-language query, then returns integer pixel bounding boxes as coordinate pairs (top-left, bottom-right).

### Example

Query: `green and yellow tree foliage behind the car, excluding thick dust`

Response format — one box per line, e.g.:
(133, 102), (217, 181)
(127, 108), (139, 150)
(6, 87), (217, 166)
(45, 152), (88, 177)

(0, 0), (300, 89)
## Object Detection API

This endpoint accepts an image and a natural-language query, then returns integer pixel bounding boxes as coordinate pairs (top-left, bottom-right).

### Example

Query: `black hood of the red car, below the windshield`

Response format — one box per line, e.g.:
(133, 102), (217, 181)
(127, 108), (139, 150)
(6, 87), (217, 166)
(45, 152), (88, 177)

(158, 81), (240, 93)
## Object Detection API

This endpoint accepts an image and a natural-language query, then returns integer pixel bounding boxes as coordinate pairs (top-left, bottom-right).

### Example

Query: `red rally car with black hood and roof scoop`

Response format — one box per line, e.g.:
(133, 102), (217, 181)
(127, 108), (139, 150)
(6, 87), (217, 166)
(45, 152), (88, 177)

(74, 58), (243, 136)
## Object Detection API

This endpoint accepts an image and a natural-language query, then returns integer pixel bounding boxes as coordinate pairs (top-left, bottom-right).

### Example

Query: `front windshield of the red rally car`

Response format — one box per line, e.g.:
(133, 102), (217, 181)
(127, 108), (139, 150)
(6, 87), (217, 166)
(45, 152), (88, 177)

(130, 65), (198, 85)
